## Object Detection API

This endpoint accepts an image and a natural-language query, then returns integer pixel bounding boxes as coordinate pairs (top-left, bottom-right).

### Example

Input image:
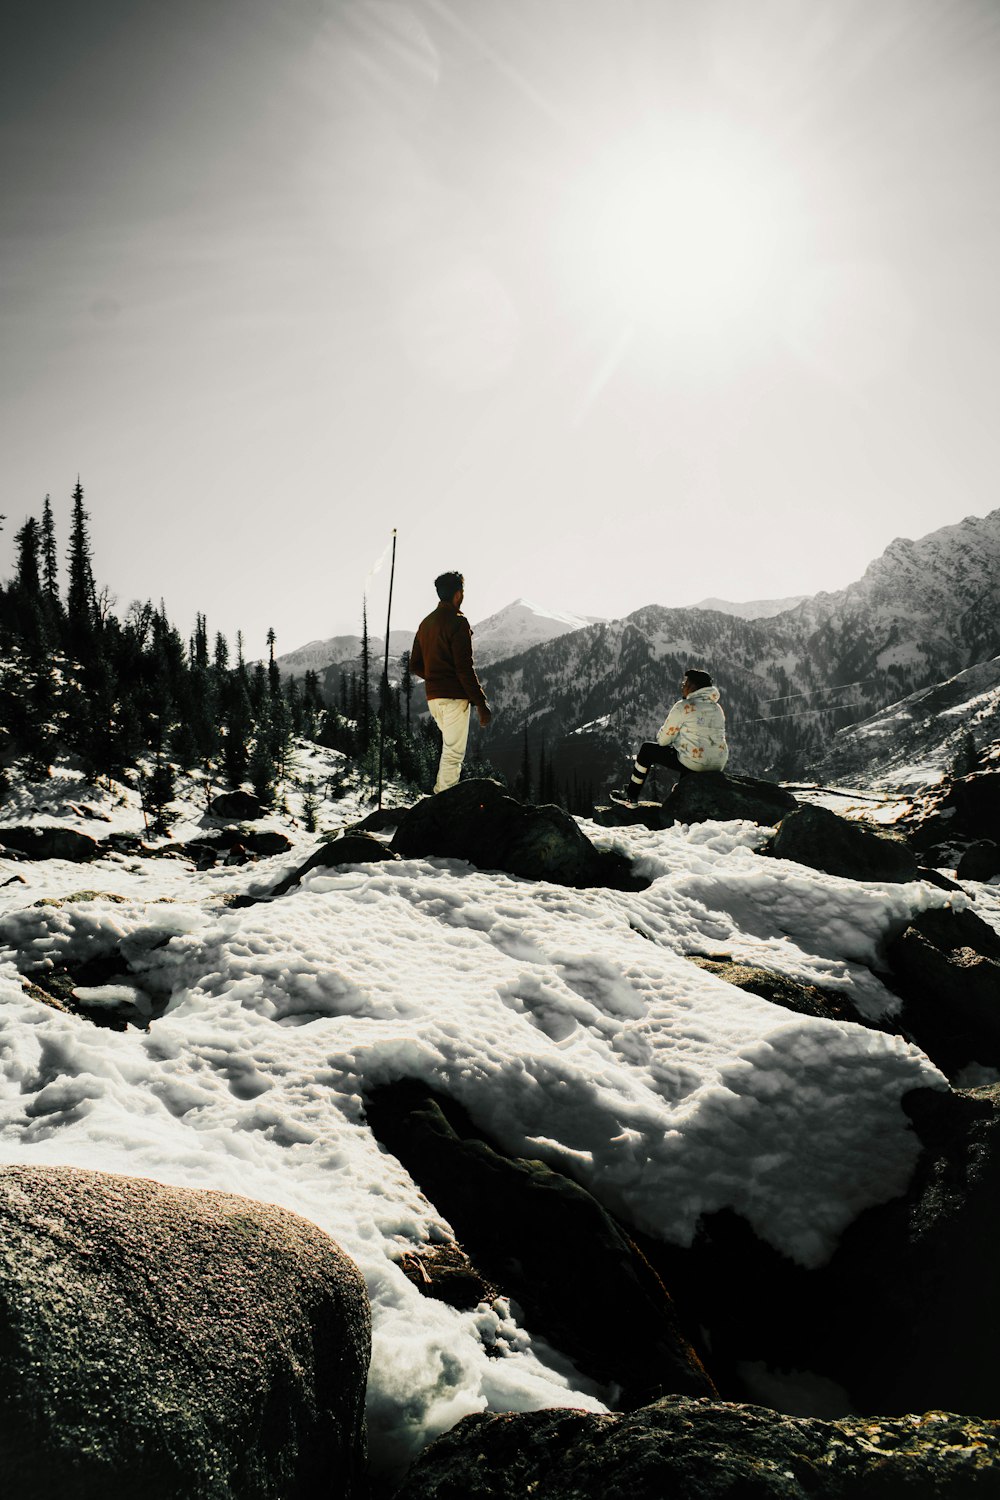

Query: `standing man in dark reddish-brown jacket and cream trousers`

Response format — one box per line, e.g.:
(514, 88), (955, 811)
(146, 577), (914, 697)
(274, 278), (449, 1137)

(409, 573), (493, 792)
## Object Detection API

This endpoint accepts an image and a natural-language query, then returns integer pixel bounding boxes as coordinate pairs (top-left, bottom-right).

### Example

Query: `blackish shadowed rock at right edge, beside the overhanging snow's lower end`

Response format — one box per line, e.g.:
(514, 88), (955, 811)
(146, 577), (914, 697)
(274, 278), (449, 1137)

(826, 1085), (1000, 1422)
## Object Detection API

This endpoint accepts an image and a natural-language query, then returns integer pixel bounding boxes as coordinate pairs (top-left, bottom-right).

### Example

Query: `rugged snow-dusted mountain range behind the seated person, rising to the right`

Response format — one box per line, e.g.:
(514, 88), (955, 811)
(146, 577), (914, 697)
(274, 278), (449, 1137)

(486, 510), (1000, 780)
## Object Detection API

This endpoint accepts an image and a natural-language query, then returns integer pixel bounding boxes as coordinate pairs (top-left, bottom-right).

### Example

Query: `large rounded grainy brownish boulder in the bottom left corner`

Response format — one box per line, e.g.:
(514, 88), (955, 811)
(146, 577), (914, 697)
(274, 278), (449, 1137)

(0, 1167), (370, 1500)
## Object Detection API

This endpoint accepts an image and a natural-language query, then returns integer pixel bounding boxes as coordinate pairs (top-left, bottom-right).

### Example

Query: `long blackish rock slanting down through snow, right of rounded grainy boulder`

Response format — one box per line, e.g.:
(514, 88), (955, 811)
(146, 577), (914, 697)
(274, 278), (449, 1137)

(366, 1082), (715, 1404)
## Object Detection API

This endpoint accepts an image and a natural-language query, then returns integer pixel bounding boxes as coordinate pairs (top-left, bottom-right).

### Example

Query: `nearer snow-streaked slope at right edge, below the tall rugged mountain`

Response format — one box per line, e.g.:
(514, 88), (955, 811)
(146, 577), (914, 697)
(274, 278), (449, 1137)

(808, 657), (1000, 791)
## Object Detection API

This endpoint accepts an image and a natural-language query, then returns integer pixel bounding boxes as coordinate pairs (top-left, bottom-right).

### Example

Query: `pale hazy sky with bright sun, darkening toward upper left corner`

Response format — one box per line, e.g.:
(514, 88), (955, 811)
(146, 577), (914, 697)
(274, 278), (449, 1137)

(0, 0), (1000, 651)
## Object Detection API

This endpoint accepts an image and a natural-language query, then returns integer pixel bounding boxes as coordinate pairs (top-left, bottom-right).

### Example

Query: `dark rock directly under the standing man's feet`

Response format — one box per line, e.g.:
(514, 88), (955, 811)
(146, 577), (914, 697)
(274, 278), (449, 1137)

(391, 780), (649, 891)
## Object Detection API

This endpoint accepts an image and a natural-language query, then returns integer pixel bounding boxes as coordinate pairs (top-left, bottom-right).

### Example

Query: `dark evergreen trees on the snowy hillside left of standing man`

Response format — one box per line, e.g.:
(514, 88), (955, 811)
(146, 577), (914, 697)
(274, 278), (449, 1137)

(0, 480), (461, 821)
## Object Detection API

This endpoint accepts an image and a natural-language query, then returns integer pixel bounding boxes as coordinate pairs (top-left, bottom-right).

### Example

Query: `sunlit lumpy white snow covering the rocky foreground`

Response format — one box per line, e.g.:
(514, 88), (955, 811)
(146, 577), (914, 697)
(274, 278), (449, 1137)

(0, 768), (983, 1472)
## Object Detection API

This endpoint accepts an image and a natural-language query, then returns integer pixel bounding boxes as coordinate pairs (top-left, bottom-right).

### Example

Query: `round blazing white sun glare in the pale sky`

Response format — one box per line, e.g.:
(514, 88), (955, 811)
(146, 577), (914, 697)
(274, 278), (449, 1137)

(558, 123), (796, 352)
